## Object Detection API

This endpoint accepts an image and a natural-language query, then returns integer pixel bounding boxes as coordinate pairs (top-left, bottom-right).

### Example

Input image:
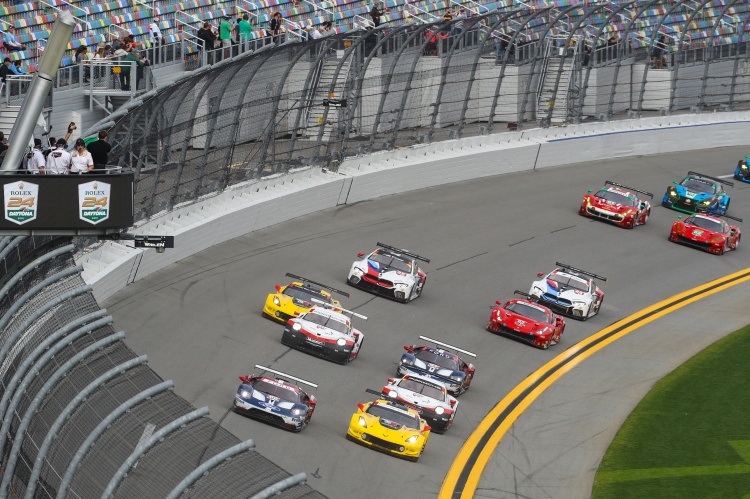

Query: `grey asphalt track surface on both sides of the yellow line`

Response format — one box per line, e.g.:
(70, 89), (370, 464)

(104, 143), (750, 498)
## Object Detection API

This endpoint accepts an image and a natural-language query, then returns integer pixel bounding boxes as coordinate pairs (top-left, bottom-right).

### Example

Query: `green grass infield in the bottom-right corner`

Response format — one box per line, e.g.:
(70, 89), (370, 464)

(592, 326), (750, 499)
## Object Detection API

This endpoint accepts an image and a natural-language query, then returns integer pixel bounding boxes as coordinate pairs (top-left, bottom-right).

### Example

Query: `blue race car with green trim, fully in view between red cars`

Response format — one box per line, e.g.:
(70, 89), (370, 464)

(661, 172), (734, 215)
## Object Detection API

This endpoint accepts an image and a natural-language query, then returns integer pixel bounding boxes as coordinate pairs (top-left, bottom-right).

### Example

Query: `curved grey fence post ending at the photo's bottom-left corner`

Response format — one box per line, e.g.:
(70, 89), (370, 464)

(0, 332), (125, 499)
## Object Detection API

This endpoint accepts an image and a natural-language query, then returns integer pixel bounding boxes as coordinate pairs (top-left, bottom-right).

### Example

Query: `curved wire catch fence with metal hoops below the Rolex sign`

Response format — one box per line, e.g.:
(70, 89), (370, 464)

(0, 237), (322, 498)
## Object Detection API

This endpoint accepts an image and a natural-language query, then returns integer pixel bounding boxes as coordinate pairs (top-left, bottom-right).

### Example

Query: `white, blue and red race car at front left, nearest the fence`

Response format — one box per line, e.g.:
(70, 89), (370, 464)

(232, 365), (318, 431)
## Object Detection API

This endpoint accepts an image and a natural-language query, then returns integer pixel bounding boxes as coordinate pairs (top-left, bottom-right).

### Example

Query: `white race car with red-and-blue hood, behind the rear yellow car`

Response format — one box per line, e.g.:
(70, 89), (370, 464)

(347, 243), (430, 303)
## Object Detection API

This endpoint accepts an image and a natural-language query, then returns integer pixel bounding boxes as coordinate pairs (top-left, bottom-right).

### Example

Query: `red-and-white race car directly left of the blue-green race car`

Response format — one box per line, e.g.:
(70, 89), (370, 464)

(578, 180), (654, 229)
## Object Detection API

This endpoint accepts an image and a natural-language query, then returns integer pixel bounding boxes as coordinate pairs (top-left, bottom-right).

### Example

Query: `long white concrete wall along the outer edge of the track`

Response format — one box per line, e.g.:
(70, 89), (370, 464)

(77, 112), (750, 301)
